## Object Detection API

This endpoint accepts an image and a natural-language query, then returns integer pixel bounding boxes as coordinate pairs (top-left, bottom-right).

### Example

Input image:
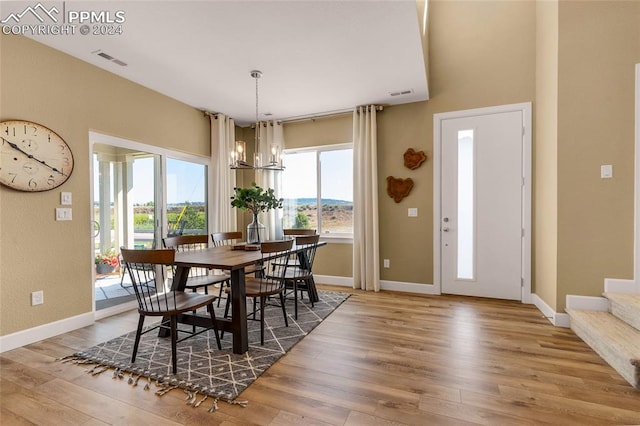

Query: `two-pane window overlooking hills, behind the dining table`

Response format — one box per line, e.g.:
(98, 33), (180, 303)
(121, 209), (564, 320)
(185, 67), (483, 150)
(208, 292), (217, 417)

(282, 144), (353, 237)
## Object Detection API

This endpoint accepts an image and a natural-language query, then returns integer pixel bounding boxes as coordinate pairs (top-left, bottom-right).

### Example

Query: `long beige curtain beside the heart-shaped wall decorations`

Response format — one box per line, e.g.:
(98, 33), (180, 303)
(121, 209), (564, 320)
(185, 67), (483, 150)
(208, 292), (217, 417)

(353, 105), (380, 291)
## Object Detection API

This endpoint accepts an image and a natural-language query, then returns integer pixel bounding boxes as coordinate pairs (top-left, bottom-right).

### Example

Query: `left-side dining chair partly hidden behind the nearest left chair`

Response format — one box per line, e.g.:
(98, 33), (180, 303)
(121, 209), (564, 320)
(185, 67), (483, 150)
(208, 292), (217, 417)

(162, 234), (230, 294)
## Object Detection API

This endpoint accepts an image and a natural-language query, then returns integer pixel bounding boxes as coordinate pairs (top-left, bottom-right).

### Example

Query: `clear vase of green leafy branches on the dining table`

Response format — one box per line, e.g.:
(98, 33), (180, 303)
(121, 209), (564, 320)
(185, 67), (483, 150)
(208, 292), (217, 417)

(231, 182), (283, 244)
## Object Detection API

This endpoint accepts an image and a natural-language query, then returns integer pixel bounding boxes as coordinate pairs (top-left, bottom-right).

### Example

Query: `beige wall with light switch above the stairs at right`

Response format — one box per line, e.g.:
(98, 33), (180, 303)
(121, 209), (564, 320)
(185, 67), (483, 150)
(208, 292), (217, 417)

(556, 1), (640, 311)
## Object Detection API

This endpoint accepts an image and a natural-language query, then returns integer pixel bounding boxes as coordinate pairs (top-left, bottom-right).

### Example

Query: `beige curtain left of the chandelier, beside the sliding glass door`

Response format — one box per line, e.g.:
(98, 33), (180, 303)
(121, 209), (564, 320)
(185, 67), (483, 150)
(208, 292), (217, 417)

(209, 114), (238, 232)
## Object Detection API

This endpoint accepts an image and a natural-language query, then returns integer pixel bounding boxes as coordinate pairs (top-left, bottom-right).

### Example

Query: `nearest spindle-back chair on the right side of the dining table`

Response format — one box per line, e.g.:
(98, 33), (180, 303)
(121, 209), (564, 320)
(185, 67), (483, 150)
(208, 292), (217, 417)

(224, 240), (293, 346)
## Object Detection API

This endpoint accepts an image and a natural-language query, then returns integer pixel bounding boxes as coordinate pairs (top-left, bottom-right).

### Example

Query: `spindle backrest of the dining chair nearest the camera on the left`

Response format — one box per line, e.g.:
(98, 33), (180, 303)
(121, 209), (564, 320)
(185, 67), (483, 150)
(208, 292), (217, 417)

(120, 248), (177, 313)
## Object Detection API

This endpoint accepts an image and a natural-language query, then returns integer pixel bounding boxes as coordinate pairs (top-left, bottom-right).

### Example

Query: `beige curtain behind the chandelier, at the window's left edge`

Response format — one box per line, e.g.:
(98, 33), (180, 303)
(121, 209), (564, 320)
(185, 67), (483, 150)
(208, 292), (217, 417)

(256, 121), (284, 240)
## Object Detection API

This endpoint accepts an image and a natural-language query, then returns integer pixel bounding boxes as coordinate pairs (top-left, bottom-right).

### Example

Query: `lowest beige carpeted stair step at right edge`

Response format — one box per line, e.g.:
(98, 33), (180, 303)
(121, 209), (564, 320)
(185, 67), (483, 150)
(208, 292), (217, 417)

(567, 309), (640, 388)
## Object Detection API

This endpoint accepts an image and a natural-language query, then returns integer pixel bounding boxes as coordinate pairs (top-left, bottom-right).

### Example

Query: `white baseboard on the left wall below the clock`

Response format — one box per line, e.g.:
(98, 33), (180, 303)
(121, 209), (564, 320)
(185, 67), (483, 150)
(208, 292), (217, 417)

(0, 312), (94, 353)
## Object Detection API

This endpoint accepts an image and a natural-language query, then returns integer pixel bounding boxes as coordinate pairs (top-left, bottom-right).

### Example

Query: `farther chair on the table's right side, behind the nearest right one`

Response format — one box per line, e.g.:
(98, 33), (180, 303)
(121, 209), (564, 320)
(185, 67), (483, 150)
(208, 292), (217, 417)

(285, 234), (320, 319)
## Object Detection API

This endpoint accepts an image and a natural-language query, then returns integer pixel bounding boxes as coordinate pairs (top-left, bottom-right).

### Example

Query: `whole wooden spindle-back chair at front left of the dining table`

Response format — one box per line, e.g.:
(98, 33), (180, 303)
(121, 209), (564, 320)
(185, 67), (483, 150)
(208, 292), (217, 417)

(121, 249), (222, 374)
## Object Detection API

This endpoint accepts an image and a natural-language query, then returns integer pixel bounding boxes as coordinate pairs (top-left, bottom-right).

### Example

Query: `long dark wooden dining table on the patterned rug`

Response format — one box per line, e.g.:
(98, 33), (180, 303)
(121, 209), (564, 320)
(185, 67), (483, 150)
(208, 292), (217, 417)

(165, 241), (326, 354)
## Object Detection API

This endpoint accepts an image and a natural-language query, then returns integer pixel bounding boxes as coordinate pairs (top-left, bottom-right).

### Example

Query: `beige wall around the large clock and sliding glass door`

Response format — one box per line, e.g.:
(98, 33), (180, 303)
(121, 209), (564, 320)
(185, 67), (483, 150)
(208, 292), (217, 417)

(0, 35), (210, 335)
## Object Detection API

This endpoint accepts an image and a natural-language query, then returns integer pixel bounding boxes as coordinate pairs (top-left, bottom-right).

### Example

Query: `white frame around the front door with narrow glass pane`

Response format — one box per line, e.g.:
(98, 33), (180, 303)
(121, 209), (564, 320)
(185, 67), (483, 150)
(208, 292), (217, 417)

(433, 102), (532, 303)
